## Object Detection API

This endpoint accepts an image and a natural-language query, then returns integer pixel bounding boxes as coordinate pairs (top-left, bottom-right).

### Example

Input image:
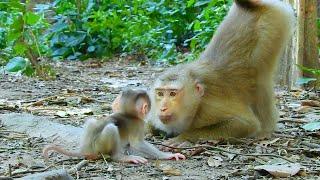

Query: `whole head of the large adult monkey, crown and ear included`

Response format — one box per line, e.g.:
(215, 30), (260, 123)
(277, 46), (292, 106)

(150, 66), (204, 131)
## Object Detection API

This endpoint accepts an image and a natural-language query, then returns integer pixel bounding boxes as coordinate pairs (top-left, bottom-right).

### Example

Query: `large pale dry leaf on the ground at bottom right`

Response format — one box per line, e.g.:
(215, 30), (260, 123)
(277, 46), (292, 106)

(254, 163), (303, 178)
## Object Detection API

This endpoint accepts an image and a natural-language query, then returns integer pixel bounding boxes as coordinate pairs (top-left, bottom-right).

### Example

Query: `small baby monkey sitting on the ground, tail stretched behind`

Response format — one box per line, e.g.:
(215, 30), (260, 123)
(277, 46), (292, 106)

(43, 89), (185, 164)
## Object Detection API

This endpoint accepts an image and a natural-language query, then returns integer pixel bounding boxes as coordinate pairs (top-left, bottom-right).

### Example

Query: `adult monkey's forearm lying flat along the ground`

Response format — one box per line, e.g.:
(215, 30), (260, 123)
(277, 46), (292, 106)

(165, 114), (260, 146)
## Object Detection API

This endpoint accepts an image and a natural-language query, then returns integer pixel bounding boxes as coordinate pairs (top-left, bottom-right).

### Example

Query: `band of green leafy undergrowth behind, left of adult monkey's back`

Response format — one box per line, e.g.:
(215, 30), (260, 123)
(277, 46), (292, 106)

(0, 0), (231, 63)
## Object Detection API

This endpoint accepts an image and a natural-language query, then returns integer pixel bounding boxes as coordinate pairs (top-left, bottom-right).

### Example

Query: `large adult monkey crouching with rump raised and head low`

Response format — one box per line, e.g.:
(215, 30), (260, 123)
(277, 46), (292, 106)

(148, 0), (294, 145)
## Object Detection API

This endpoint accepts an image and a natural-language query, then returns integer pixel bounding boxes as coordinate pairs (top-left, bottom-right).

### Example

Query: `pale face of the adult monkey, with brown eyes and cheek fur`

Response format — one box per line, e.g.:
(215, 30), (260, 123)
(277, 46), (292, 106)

(152, 75), (203, 127)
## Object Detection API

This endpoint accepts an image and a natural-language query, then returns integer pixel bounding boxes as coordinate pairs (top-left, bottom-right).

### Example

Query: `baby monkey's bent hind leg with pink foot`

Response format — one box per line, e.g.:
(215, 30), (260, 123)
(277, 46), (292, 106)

(95, 124), (147, 164)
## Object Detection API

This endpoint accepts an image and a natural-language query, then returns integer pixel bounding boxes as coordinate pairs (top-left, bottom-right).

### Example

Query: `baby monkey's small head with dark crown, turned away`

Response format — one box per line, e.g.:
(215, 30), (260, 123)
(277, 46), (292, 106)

(112, 89), (151, 119)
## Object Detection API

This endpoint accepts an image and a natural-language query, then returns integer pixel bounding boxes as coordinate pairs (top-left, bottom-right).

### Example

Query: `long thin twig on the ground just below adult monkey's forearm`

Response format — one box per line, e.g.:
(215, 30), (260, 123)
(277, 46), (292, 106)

(154, 143), (295, 163)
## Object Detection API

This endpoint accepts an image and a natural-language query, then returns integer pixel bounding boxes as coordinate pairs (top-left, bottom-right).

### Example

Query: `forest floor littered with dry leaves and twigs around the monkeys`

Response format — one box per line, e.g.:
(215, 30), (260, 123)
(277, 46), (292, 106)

(0, 61), (320, 179)
